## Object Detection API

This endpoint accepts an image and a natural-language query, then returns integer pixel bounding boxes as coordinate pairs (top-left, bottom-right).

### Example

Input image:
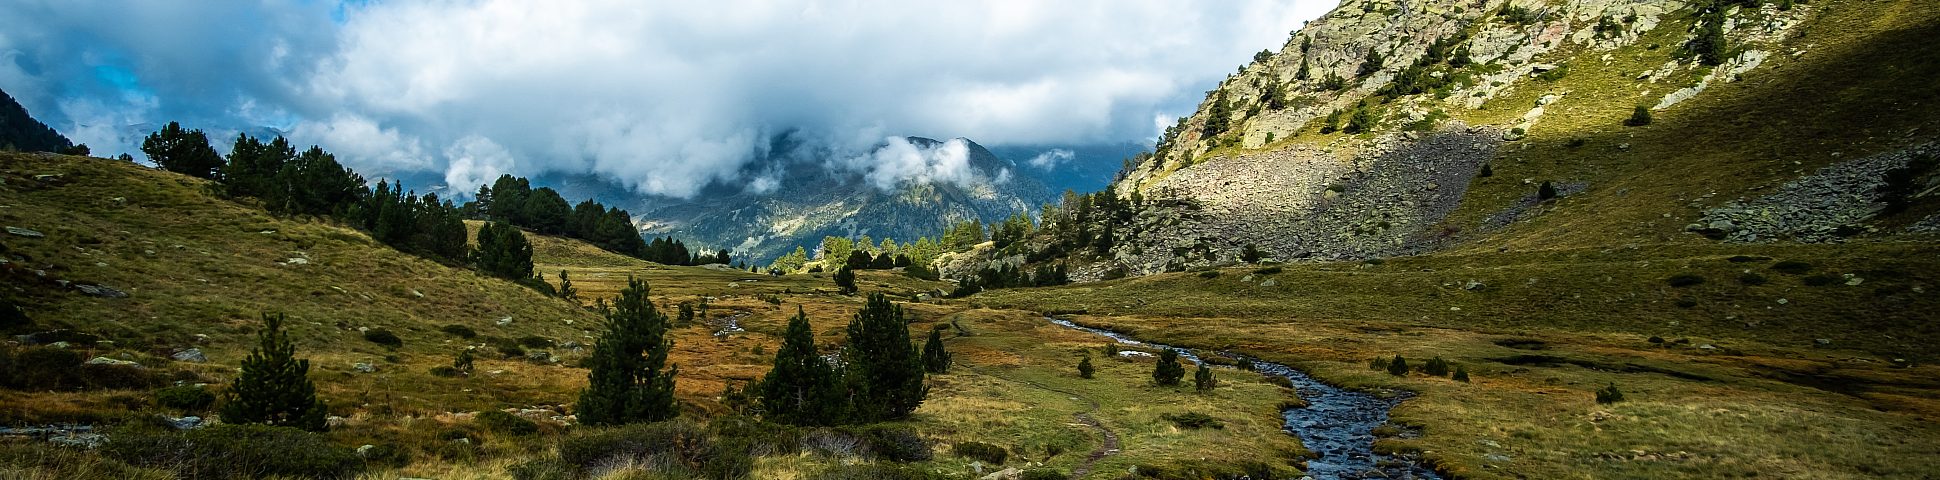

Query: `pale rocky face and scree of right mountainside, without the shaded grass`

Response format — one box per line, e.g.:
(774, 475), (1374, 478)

(1073, 0), (1812, 280)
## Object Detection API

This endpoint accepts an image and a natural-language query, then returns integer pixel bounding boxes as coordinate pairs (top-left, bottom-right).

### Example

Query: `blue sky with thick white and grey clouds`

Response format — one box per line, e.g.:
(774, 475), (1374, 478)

(0, 0), (1337, 196)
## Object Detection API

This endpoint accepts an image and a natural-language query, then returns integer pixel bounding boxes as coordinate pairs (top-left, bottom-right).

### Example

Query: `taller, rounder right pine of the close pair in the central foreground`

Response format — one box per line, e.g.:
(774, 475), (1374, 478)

(842, 293), (929, 422)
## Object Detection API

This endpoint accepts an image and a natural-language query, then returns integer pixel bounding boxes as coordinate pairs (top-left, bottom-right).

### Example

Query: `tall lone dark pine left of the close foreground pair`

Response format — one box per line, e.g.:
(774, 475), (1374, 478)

(576, 276), (681, 426)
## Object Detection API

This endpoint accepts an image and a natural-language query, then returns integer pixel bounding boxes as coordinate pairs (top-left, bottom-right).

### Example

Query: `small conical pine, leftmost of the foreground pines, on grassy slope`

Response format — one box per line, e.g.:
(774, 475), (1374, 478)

(221, 313), (328, 431)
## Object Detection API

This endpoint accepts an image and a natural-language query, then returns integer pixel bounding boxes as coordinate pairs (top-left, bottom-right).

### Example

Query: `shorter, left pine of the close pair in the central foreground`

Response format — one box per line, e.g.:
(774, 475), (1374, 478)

(757, 305), (848, 426)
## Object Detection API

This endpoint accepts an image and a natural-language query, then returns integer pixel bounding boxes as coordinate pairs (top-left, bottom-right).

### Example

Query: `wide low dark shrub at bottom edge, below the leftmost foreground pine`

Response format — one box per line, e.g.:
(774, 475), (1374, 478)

(101, 424), (365, 478)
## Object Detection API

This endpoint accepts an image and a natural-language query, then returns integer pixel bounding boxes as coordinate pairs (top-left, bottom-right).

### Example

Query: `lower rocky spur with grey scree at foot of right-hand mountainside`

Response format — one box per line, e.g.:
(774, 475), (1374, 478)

(1075, 122), (1500, 280)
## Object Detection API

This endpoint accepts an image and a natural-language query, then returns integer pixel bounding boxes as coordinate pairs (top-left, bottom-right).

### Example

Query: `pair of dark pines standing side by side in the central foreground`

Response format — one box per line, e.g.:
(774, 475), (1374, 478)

(751, 293), (949, 426)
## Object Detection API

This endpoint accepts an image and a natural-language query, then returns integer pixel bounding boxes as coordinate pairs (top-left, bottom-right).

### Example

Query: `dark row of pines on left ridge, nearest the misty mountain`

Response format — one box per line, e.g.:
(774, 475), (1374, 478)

(466, 175), (733, 264)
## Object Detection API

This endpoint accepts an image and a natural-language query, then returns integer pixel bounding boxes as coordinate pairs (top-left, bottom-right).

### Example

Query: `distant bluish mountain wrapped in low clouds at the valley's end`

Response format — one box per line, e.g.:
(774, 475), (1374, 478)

(624, 136), (1055, 262)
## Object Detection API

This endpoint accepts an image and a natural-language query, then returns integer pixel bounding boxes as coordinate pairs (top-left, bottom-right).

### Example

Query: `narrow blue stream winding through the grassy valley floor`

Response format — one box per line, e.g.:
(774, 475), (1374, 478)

(1048, 319), (1439, 478)
